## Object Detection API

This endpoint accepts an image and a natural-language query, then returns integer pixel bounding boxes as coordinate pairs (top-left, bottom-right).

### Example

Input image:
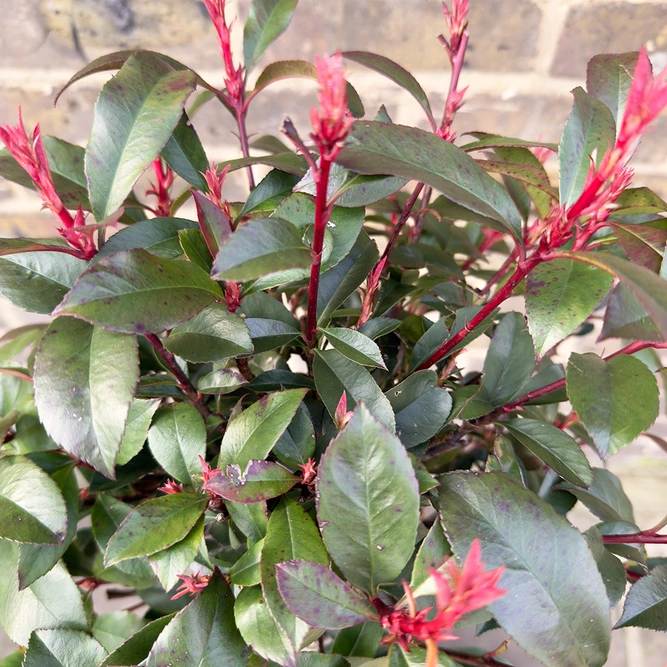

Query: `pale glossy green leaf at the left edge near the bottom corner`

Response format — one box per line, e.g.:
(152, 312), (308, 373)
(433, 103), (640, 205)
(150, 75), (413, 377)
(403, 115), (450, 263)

(0, 540), (88, 646)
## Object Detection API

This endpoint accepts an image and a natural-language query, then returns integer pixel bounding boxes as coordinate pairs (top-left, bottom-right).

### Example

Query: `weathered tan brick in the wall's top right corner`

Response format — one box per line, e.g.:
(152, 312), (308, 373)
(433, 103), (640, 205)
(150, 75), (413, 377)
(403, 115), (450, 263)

(551, 2), (667, 77)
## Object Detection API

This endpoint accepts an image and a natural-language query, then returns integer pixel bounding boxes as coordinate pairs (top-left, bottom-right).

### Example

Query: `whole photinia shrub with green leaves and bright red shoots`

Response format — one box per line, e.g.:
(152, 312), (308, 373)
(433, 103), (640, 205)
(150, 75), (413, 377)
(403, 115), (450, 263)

(0, 0), (667, 667)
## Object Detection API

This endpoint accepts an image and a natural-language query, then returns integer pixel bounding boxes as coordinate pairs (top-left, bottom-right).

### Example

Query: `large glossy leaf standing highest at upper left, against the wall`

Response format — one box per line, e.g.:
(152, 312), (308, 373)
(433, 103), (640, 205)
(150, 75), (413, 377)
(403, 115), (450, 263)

(86, 52), (196, 221)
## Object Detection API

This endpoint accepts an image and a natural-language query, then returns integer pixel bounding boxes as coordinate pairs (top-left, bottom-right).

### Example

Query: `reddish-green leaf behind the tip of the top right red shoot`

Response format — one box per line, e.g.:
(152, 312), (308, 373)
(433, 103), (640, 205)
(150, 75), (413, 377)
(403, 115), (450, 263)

(586, 51), (638, 126)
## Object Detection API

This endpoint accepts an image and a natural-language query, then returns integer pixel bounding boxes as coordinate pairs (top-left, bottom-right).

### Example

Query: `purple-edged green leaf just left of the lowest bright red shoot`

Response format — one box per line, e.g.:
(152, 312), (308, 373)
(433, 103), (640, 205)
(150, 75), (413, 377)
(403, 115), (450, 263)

(276, 560), (377, 630)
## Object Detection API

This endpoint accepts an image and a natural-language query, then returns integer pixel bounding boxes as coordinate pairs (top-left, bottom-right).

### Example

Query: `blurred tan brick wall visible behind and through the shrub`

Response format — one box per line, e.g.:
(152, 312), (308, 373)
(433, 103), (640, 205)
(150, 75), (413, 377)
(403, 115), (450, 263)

(0, 0), (667, 667)
